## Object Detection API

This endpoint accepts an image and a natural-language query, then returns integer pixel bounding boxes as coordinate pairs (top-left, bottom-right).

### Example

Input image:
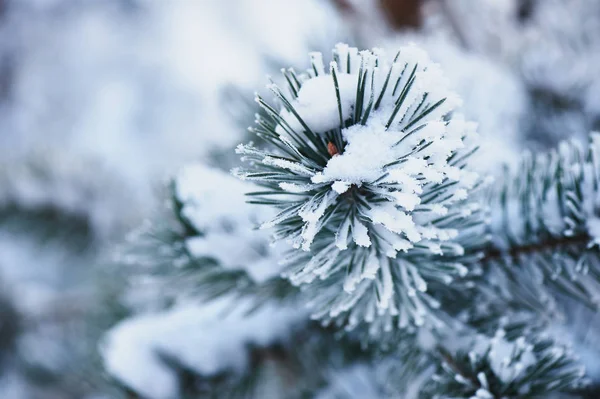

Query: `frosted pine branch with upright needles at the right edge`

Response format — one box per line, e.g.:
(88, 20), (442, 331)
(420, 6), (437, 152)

(482, 134), (600, 308)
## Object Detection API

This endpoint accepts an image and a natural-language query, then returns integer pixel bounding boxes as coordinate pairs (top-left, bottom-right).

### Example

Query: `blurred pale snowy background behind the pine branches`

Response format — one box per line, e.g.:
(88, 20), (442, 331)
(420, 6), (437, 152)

(0, 0), (600, 399)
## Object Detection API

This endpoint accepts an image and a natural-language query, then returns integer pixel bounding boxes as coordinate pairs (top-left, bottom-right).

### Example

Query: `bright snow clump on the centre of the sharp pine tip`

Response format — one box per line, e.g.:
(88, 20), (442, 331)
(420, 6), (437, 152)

(311, 111), (478, 256)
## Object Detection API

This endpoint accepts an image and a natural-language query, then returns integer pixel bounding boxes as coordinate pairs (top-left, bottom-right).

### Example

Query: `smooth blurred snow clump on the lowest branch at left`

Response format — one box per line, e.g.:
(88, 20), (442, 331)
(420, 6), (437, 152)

(101, 298), (306, 399)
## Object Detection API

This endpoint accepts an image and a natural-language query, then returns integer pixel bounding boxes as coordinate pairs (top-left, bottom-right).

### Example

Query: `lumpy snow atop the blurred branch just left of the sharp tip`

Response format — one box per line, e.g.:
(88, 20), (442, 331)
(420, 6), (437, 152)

(175, 164), (284, 282)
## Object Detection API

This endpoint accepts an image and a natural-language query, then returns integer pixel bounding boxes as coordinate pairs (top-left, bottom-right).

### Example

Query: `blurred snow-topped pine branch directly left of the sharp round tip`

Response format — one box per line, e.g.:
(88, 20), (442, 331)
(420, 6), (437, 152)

(120, 165), (299, 308)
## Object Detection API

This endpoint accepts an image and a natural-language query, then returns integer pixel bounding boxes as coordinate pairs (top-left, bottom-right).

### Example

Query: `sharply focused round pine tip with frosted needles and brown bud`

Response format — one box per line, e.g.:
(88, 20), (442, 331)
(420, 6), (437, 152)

(234, 44), (484, 332)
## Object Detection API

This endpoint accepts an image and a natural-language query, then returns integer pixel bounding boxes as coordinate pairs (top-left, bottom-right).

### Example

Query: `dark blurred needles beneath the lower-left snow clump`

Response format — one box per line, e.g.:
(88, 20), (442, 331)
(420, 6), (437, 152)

(109, 323), (370, 399)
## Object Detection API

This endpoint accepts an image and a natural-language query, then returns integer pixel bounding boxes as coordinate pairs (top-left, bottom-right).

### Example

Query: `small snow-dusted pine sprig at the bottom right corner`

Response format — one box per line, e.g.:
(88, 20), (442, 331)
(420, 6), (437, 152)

(421, 324), (586, 399)
